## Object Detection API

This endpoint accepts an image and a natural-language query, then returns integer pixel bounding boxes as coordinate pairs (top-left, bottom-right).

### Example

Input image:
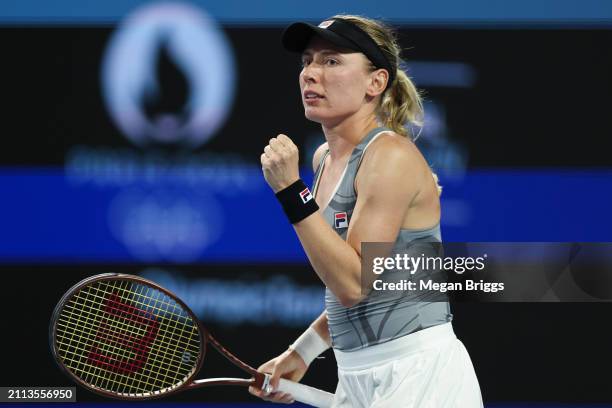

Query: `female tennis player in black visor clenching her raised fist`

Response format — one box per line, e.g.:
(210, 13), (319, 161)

(250, 15), (482, 408)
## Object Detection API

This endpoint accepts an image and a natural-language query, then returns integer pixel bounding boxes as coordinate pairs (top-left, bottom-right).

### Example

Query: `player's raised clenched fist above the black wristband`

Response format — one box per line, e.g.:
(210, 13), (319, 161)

(261, 134), (300, 193)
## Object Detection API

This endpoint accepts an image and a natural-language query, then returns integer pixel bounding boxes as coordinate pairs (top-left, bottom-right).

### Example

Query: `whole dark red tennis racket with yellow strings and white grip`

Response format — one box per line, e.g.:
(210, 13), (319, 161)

(49, 274), (333, 407)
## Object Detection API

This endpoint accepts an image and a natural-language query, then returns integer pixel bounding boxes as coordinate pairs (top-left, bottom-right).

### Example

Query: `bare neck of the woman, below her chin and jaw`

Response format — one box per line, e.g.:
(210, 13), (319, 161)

(323, 115), (379, 161)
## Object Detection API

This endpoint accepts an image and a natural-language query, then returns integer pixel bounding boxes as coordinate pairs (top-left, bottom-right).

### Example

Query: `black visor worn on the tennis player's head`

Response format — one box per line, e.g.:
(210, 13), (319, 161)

(282, 18), (395, 88)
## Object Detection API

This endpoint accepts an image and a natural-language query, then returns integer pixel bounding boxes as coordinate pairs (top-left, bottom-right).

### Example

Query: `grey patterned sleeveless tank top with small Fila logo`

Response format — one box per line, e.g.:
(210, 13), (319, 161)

(313, 127), (453, 351)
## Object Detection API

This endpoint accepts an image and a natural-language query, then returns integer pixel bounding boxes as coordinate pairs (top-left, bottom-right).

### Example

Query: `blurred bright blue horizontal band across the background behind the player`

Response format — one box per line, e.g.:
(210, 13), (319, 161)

(0, 169), (612, 263)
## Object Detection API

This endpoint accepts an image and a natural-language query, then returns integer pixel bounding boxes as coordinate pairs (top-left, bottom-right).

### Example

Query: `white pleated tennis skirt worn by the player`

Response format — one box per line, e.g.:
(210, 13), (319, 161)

(333, 323), (483, 408)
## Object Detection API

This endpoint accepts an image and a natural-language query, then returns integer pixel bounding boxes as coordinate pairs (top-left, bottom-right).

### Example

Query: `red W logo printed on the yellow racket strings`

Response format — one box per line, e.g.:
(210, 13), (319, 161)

(87, 293), (159, 374)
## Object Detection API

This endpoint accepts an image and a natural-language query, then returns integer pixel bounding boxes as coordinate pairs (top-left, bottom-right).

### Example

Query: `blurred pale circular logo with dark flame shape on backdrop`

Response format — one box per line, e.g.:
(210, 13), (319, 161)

(102, 3), (235, 148)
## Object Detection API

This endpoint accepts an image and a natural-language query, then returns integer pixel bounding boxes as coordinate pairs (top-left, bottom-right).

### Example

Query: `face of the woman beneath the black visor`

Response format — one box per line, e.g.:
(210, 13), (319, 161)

(300, 36), (371, 124)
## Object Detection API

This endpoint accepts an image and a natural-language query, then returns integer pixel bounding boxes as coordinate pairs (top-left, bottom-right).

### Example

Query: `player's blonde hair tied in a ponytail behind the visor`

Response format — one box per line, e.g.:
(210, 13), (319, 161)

(332, 14), (442, 194)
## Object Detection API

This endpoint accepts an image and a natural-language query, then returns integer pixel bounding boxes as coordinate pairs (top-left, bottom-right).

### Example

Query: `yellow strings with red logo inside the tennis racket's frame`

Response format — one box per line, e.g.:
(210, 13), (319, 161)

(55, 280), (201, 395)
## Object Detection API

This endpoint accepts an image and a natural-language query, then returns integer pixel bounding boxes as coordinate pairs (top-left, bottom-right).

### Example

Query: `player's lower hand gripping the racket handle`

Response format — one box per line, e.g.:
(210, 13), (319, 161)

(249, 350), (308, 404)
